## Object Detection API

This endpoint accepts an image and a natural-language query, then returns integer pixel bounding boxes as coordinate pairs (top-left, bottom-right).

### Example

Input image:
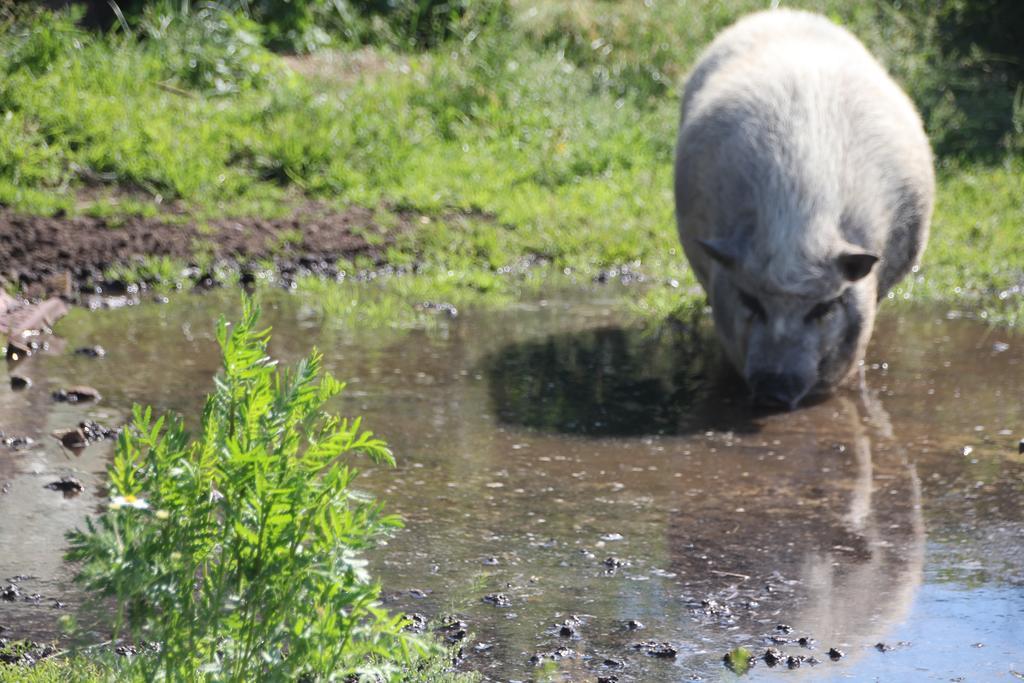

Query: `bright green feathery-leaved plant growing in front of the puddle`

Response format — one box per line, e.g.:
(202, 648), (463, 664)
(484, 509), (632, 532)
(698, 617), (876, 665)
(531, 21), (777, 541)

(68, 299), (433, 681)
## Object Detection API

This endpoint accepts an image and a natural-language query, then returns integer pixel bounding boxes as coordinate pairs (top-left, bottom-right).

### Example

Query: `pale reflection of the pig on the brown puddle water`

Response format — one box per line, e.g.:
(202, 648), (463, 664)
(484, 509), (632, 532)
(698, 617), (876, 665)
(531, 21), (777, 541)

(670, 392), (925, 660)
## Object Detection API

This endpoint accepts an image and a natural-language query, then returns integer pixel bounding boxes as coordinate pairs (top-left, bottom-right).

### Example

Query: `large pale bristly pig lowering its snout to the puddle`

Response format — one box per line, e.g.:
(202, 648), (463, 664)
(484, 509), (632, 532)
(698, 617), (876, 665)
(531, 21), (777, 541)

(675, 9), (935, 410)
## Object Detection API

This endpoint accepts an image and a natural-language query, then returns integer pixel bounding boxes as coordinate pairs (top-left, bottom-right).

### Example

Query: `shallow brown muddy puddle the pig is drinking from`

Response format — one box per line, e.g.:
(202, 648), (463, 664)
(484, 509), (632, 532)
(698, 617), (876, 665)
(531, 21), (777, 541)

(0, 293), (1024, 681)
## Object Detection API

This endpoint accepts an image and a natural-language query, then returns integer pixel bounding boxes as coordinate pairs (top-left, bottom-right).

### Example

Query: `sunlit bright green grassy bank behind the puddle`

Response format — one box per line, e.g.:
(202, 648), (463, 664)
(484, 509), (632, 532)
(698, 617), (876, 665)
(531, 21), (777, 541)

(0, 0), (1024, 325)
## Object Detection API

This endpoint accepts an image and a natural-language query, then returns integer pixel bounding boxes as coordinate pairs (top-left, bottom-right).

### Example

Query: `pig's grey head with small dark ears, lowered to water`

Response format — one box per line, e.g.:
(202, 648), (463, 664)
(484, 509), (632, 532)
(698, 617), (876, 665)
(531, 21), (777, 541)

(699, 241), (879, 410)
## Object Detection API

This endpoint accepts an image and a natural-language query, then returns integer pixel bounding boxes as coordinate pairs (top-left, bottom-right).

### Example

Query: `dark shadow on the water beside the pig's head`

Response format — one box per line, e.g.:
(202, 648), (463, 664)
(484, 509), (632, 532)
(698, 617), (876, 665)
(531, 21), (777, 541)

(483, 326), (757, 436)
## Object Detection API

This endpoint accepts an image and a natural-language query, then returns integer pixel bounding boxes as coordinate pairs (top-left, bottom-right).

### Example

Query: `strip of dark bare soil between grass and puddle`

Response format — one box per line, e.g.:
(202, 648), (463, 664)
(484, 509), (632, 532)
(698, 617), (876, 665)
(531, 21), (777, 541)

(0, 204), (415, 296)
